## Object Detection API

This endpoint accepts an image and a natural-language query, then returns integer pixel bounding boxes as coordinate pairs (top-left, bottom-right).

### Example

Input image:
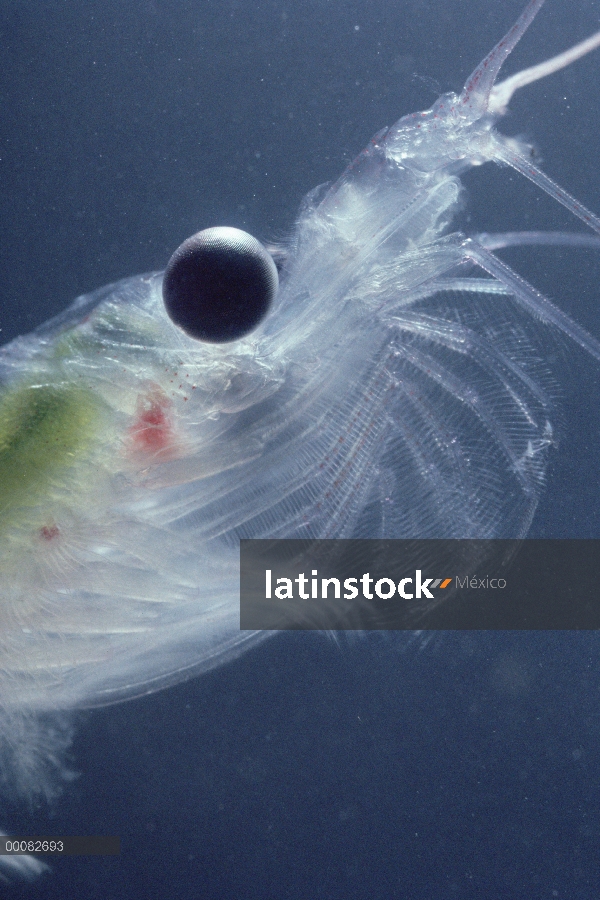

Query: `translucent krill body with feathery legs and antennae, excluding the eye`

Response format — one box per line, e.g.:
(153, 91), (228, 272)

(0, 0), (600, 876)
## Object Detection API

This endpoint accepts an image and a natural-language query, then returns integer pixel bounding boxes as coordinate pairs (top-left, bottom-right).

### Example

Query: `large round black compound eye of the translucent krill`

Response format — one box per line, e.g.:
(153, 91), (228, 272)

(163, 228), (279, 344)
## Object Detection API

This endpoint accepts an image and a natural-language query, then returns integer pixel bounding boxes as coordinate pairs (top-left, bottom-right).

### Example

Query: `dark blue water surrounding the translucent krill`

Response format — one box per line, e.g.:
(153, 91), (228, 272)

(0, 0), (600, 900)
